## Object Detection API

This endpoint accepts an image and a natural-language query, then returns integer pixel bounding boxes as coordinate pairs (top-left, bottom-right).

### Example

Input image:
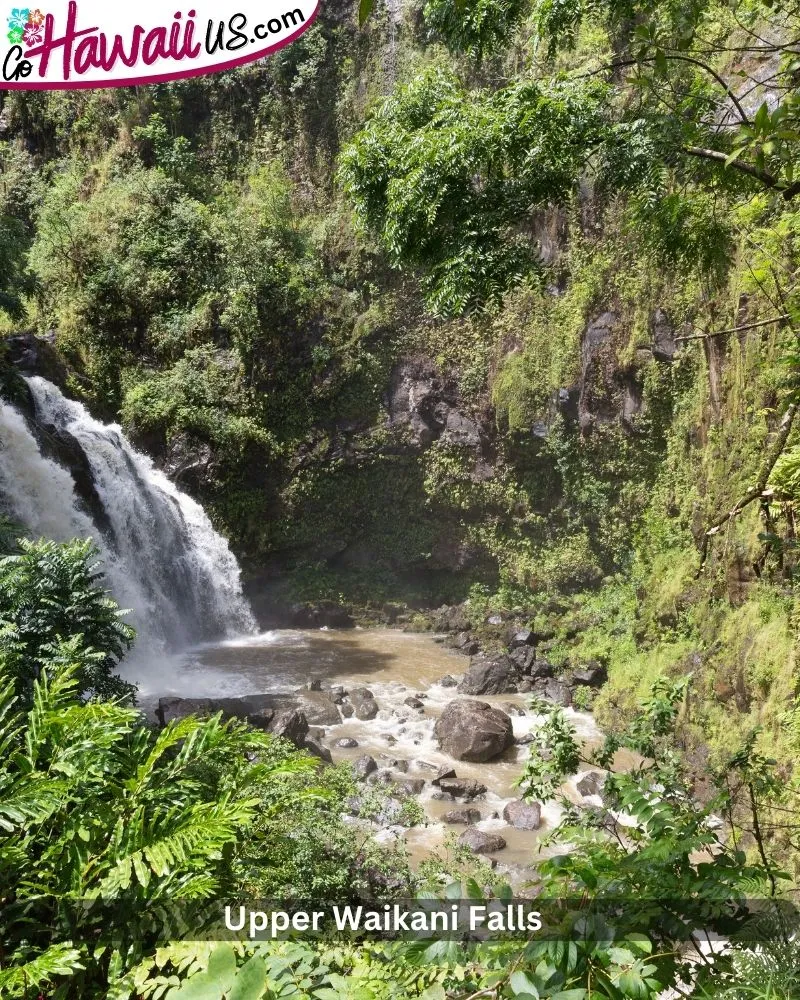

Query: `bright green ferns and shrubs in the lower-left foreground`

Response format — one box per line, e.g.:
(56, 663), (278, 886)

(0, 541), (418, 998)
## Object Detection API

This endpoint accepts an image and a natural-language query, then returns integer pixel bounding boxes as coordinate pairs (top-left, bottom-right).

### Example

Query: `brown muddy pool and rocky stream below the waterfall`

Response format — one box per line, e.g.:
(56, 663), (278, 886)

(138, 629), (602, 874)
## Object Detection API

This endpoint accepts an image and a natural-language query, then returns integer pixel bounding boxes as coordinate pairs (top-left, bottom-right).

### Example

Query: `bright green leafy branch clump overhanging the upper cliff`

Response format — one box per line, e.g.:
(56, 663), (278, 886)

(341, 72), (602, 315)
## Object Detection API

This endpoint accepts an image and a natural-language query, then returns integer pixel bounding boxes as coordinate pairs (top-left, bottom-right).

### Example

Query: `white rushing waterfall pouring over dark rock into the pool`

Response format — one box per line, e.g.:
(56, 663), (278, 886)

(0, 377), (255, 660)
